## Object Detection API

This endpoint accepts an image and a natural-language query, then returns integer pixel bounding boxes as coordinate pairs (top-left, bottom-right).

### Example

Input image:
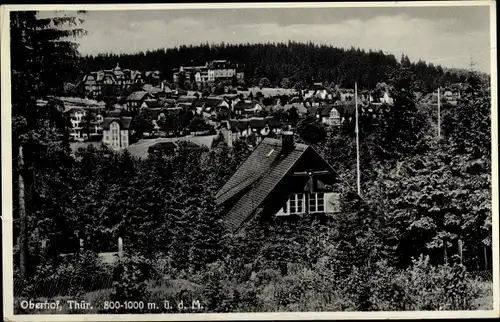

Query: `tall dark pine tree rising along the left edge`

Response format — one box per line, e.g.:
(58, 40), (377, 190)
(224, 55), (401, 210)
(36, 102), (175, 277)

(10, 11), (83, 275)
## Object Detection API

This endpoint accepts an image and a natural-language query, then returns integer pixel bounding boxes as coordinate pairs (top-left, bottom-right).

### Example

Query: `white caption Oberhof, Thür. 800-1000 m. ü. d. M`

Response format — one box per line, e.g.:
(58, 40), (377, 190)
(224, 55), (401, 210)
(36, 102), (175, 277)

(21, 300), (203, 311)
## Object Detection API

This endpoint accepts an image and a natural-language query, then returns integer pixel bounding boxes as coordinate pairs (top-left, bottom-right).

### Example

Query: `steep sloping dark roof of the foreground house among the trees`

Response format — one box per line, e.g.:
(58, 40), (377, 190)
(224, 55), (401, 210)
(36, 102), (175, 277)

(216, 138), (309, 231)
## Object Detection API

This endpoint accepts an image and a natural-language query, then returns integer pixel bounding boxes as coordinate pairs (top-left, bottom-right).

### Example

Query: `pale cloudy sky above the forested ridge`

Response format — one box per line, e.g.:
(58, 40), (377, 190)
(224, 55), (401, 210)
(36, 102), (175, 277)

(44, 6), (490, 72)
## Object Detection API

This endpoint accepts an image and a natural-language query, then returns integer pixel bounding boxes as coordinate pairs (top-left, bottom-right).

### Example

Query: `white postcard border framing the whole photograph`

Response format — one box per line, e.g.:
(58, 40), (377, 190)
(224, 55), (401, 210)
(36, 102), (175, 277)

(0, 0), (500, 321)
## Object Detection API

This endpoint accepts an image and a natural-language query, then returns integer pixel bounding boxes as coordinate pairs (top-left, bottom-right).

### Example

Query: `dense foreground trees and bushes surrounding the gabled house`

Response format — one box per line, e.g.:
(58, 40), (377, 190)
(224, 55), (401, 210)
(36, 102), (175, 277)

(11, 12), (492, 314)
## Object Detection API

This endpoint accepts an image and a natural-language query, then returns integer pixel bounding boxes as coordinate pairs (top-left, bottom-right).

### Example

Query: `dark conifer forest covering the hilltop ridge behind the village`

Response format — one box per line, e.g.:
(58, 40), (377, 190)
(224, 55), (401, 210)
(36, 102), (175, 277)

(79, 41), (480, 92)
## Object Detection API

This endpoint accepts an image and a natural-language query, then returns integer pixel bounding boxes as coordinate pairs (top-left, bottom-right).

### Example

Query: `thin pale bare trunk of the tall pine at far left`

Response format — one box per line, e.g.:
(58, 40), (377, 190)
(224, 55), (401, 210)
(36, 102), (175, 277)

(19, 146), (28, 278)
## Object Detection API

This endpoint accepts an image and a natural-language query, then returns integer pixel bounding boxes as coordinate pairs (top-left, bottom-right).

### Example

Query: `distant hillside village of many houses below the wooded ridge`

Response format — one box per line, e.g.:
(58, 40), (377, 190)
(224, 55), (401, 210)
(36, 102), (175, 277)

(45, 60), (466, 156)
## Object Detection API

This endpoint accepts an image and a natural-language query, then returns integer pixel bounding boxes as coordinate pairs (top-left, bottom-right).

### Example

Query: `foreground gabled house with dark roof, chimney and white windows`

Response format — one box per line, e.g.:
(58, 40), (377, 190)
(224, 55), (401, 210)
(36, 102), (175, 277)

(216, 132), (341, 233)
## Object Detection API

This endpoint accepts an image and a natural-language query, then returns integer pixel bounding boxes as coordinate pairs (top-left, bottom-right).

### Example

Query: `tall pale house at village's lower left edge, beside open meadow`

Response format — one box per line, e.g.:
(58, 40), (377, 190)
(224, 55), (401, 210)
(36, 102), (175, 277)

(102, 117), (132, 150)
